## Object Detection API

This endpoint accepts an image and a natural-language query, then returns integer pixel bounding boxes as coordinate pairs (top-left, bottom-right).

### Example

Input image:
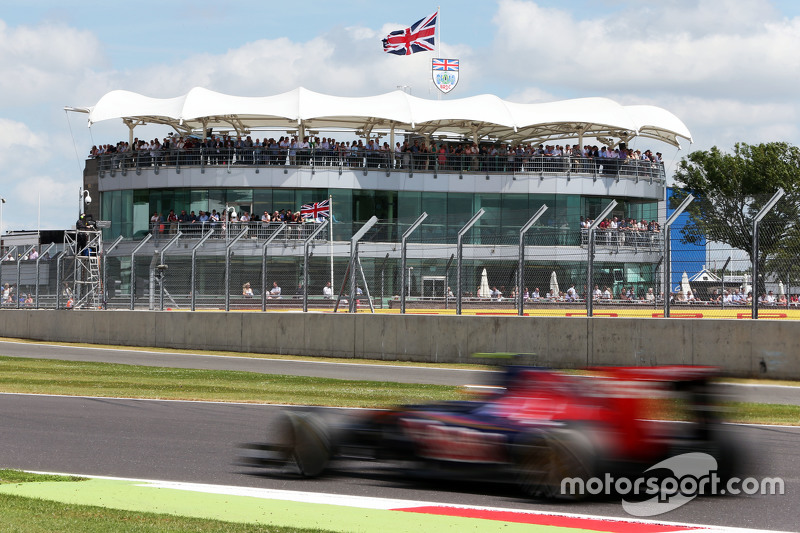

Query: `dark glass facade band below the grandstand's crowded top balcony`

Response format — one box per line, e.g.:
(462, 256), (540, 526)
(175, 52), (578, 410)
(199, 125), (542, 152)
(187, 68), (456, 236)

(101, 188), (658, 245)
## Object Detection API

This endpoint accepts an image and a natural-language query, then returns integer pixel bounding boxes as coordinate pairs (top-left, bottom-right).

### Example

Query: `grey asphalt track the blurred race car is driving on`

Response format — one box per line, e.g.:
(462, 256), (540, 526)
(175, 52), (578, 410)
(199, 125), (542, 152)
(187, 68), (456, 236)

(0, 394), (800, 531)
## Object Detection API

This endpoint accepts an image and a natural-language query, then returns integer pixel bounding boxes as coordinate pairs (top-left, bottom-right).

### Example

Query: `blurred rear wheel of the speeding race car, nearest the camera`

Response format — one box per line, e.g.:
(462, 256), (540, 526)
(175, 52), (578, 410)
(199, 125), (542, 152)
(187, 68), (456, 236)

(517, 429), (594, 500)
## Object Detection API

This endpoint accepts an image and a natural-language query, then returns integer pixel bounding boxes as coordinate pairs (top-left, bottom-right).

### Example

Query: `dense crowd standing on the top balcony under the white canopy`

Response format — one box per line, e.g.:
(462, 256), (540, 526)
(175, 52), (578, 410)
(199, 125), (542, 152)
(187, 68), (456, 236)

(89, 135), (663, 176)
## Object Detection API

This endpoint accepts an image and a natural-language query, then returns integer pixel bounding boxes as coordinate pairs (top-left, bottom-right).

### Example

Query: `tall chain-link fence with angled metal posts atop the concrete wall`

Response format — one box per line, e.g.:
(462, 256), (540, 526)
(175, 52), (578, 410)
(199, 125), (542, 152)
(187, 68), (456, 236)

(0, 190), (800, 319)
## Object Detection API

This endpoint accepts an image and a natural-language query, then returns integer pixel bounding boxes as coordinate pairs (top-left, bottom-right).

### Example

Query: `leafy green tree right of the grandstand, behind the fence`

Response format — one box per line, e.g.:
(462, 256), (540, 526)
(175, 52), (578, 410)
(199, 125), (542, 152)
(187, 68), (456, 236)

(672, 142), (800, 298)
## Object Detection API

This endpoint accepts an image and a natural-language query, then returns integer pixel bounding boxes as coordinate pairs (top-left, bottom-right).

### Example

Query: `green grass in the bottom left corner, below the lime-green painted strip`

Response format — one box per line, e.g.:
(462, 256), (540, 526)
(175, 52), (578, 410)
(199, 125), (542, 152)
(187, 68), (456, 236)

(0, 494), (332, 533)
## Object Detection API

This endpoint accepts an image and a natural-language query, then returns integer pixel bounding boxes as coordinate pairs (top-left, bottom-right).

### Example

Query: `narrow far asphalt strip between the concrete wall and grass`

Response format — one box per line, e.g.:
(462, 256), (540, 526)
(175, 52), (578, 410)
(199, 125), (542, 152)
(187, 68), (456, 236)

(0, 341), (800, 405)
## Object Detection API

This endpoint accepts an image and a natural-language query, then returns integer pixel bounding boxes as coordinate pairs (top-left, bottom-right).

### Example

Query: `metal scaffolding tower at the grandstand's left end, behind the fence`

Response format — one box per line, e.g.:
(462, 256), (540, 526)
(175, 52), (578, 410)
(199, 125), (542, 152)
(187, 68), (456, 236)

(63, 229), (105, 309)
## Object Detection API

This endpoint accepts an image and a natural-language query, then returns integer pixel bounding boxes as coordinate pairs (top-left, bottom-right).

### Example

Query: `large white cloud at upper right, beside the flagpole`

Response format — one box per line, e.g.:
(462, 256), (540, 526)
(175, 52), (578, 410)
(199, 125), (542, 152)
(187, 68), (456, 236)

(494, 0), (800, 99)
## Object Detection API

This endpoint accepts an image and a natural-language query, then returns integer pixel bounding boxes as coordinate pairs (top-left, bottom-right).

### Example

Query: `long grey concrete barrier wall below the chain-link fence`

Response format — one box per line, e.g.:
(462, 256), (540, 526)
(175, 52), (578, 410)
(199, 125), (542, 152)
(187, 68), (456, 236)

(0, 310), (800, 379)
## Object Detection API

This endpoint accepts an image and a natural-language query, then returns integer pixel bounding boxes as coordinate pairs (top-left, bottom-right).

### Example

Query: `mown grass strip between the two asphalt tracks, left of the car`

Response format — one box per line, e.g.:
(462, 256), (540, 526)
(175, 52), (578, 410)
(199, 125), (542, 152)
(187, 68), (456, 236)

(0, 357), (460, 407)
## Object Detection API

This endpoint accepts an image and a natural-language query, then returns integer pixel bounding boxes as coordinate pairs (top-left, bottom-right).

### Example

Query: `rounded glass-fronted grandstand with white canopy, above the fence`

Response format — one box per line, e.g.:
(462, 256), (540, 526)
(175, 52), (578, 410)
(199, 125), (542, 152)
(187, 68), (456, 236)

(70, 88), (691, 294)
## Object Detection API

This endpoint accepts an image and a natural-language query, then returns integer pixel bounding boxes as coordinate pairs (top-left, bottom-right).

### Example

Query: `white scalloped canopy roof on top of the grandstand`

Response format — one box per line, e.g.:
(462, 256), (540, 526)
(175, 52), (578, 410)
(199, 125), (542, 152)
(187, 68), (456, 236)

(68, 87), (692, 147)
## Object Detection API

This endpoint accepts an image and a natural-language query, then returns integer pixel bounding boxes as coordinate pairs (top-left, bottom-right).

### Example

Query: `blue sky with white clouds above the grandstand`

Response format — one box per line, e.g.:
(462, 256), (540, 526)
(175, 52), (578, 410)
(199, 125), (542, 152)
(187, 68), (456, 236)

(0, 0), (800, 230)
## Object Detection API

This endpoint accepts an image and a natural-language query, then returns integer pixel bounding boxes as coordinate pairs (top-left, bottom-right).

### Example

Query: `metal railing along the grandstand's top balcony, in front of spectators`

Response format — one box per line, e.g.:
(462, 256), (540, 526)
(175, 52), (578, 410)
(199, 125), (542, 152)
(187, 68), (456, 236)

(97, 147), (665, 181)
